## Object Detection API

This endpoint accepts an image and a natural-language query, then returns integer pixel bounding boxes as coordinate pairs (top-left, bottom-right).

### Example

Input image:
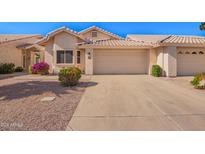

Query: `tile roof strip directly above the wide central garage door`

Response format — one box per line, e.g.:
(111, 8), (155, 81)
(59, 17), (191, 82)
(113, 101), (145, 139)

(78, 39), (154, 48)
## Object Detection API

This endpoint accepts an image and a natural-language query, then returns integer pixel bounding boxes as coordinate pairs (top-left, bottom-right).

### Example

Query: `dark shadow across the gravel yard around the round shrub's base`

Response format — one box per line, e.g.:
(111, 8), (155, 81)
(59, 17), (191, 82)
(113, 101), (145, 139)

(0, 81), (97, 100)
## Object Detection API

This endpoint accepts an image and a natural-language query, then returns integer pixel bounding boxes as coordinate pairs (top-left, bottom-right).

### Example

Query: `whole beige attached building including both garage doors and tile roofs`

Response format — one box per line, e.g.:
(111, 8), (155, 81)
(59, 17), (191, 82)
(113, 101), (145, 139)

(37, 26), (205, 76)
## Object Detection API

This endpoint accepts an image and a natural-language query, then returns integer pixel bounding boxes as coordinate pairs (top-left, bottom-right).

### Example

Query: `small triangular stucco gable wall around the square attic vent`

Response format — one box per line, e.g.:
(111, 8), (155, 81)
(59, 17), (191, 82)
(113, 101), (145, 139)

(82, 30), (113, 40)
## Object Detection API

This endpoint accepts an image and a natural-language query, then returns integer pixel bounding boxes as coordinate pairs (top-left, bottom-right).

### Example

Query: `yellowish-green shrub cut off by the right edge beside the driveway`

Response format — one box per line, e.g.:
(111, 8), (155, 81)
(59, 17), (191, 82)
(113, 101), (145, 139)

(191, 73), (205, 89)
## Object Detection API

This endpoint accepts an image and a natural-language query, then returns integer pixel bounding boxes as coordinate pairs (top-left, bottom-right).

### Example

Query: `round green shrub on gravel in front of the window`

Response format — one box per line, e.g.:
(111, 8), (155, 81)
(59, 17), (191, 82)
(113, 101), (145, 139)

(58, 67), (81, 86)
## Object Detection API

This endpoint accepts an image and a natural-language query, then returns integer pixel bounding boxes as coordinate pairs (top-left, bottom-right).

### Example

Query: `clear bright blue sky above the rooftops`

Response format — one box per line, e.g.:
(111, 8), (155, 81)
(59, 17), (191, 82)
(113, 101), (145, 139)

(0, 22), (205, 37)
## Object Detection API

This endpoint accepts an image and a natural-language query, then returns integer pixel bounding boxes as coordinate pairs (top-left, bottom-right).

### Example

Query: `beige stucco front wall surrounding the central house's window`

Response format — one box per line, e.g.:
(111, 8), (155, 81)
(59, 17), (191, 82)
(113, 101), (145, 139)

(45, 32), (85, 73)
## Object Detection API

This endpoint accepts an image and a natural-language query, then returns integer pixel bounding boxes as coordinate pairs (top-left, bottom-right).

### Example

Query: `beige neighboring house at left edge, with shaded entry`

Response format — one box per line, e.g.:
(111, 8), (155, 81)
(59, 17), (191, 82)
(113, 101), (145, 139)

(0, 34), (44, 69)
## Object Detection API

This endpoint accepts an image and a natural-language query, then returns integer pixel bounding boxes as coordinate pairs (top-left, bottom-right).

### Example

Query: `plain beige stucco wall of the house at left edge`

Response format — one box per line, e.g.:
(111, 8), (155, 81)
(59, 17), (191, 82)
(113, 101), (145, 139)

(0, 45), (22, 66)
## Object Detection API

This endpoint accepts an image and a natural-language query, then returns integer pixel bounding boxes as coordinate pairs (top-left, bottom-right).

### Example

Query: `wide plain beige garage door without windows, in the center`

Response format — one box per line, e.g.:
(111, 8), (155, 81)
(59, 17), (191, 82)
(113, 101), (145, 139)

(93, 50), (147, 74)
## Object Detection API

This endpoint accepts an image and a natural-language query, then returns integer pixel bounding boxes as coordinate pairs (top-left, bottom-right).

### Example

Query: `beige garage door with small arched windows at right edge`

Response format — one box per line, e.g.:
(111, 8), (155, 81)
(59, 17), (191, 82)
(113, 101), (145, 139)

(177, 50), (205, 75)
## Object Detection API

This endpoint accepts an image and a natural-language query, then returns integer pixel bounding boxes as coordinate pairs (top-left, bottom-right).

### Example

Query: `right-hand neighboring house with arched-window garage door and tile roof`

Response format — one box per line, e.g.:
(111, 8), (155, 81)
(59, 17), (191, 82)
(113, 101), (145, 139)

(127, 35), (205, 76)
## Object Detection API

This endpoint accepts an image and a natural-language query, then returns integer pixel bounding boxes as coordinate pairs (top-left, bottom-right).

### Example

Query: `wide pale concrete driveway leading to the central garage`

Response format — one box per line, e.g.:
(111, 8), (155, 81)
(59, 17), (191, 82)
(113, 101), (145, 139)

(68, 75), (205, 130)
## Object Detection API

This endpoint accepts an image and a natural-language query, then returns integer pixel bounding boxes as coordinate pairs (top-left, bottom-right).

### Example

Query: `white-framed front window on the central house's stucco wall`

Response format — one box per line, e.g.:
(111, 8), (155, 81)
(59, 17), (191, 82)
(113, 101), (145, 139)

(57, 50), (73, 64)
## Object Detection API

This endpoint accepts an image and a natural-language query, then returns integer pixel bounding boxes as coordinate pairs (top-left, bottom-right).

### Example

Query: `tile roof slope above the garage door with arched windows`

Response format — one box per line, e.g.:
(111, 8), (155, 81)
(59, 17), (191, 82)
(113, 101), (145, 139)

(161, 35), (205, 45)
